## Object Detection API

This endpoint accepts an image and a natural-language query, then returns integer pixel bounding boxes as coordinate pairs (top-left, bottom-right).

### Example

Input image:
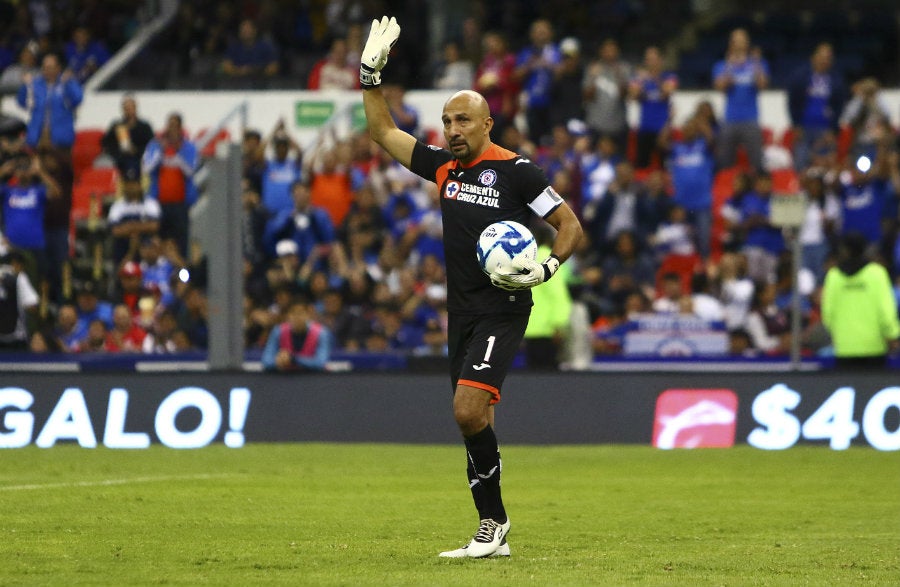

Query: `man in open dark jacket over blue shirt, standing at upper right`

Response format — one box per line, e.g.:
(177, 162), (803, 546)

(787, 43), (847, 171)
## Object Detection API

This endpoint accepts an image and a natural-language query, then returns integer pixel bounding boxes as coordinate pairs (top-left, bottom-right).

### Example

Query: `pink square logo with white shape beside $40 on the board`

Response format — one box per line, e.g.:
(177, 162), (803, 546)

(653, 389), (737, 448)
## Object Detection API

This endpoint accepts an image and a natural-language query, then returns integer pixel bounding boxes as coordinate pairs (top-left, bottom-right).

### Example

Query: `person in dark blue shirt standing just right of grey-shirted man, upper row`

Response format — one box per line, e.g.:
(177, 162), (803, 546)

(628, 46), (678, 169)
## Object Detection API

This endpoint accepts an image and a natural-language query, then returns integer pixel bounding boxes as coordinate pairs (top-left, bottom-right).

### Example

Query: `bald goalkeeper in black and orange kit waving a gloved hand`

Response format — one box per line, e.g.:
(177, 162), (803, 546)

(359, 17), (581, 558)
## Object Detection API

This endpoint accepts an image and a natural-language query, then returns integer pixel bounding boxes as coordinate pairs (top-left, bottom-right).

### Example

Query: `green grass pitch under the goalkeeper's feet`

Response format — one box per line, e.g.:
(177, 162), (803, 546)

(0, 444), (900, 586)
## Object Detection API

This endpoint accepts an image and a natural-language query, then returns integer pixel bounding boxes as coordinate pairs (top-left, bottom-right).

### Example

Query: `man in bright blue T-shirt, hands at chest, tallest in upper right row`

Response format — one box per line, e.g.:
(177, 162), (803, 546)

(712, 29), (769, 171)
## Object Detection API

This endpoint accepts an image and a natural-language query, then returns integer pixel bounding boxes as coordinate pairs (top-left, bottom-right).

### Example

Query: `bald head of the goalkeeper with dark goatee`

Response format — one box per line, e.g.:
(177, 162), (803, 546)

(441, 90), (494, 164)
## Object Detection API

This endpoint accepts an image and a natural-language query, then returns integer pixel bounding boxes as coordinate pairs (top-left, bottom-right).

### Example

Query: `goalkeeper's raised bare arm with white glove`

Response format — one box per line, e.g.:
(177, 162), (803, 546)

(359, 16), (416, 167)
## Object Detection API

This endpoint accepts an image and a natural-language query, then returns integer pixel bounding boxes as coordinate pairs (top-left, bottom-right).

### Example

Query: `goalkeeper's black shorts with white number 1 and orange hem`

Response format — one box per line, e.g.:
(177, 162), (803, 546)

(447, 314), (528, 404)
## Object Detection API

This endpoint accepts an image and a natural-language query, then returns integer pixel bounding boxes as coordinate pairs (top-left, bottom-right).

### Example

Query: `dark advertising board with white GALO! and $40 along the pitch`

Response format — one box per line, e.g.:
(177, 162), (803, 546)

(0, 372), (900, 451)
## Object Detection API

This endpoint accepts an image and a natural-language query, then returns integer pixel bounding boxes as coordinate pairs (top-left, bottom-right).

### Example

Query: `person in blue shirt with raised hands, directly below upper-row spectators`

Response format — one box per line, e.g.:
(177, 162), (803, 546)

(660, 115), (715, 257)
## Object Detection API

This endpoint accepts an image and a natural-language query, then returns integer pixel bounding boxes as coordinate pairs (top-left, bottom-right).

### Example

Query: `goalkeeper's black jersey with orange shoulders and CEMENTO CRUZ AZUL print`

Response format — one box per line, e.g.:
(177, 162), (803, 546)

(410, 142), (562, 314)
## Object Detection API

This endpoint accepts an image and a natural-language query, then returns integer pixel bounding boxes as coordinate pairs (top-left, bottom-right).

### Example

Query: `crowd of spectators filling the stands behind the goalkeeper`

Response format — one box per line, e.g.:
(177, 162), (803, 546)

(0, 1), (900, 364)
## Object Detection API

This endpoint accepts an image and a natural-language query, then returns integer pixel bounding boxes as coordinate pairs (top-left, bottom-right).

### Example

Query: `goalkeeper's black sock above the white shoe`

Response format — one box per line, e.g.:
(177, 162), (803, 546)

(464, 425), (506, 524)
